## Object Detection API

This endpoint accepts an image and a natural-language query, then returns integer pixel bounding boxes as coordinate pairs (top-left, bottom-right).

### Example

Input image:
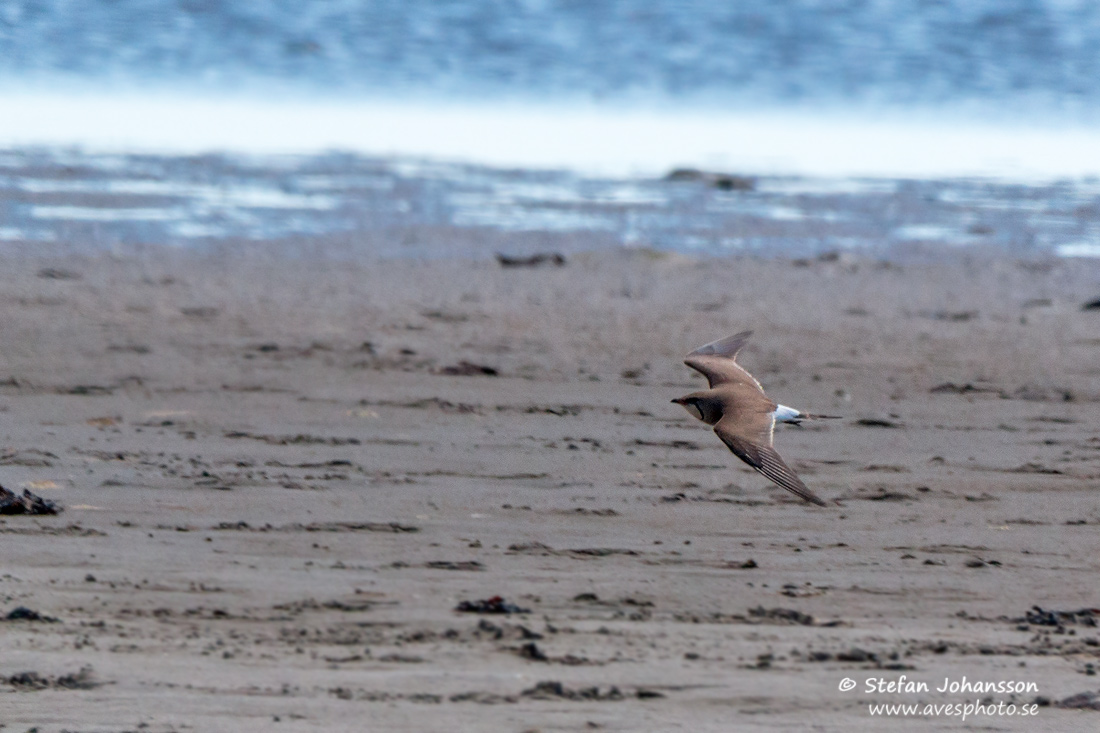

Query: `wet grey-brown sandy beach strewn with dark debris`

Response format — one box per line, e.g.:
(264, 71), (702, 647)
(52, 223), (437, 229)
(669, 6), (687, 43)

(0, 250), (1100, 733)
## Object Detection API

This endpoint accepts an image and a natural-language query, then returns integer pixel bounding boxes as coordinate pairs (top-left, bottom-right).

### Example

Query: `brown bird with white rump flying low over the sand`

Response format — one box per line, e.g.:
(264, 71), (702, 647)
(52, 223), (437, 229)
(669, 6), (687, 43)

(672, 331), (832, 506)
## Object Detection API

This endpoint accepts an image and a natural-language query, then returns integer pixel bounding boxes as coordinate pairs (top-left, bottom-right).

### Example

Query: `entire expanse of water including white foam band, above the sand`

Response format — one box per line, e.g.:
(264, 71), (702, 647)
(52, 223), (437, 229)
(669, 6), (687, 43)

(0, 0), (1100, 256)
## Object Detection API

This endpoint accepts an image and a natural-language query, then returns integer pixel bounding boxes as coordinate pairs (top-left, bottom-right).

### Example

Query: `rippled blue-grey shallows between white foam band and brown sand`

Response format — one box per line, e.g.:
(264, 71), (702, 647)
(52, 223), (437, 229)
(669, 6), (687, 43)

(0, 150), (1100, 260)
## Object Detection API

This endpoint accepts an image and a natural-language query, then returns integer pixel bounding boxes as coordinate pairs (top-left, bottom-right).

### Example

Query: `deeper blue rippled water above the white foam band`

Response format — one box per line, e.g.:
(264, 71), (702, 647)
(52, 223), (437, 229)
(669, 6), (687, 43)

(0, 0), (1100, 114)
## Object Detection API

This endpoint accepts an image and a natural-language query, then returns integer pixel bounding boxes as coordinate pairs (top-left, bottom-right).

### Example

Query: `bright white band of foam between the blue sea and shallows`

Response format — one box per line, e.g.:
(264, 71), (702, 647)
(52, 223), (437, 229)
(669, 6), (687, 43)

(0, 90), (1100, 180)
